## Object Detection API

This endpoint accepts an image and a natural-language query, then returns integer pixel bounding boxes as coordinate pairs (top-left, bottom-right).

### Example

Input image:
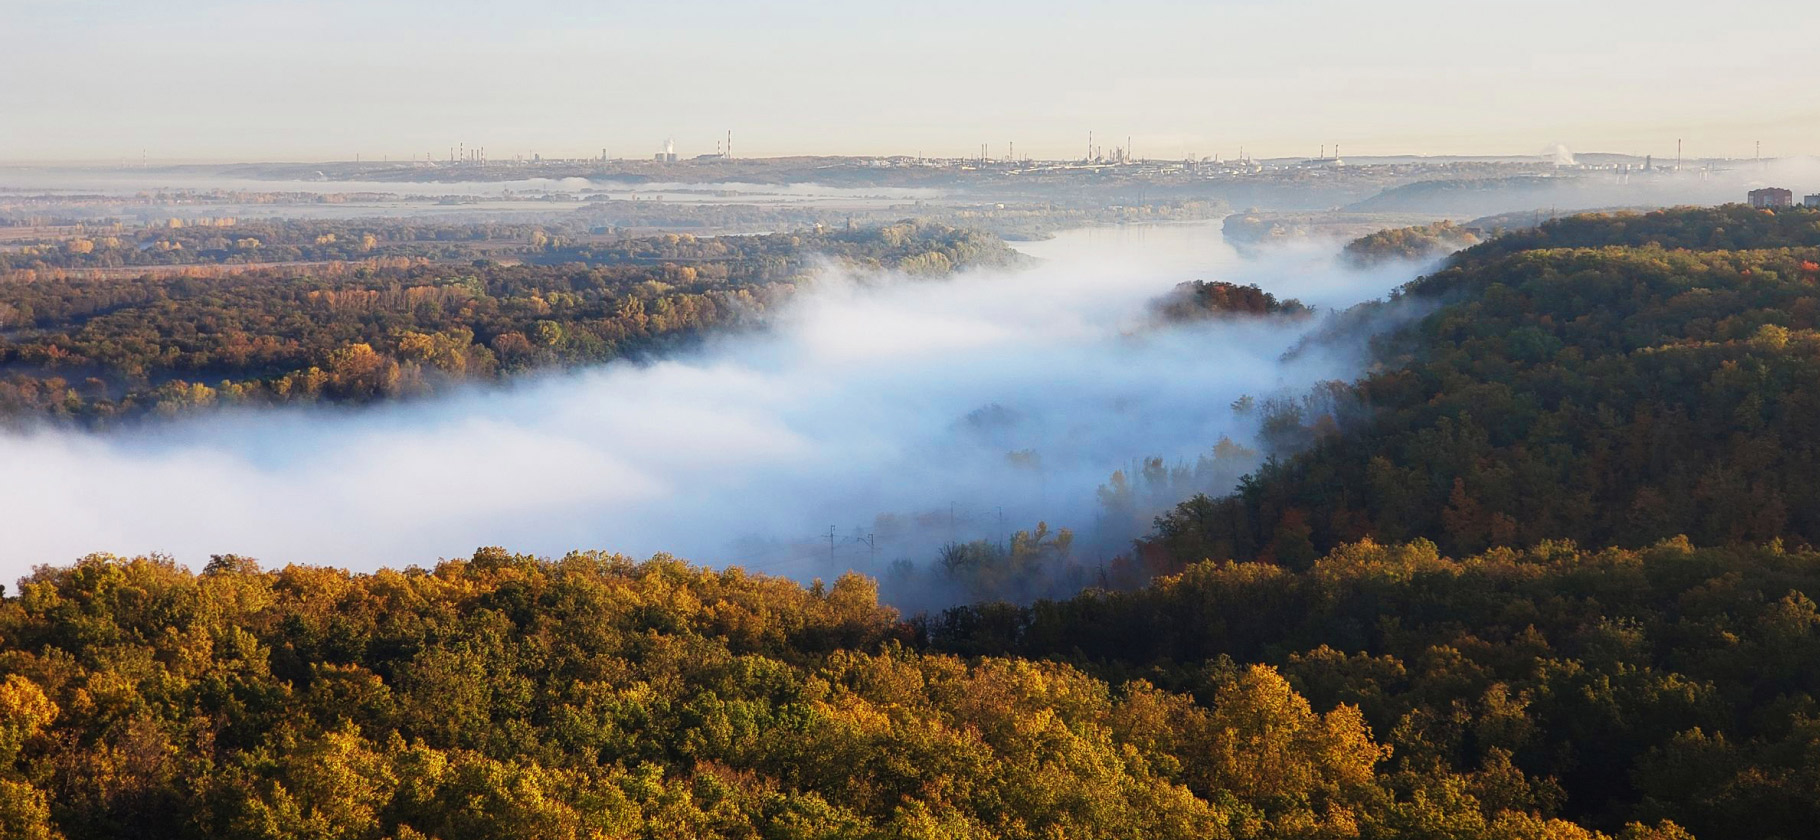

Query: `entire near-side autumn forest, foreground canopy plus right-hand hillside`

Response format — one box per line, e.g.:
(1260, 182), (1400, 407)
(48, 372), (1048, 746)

(0, 207), (1820, 840)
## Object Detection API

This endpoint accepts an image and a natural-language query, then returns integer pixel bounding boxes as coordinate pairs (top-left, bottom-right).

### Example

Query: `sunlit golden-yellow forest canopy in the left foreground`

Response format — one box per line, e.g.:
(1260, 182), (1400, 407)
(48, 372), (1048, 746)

(0, 549), (1674, 840)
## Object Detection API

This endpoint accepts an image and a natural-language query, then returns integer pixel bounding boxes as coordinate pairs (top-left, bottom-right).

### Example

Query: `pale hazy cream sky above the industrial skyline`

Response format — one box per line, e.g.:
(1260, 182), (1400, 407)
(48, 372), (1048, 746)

(0, 0), (1820, 162)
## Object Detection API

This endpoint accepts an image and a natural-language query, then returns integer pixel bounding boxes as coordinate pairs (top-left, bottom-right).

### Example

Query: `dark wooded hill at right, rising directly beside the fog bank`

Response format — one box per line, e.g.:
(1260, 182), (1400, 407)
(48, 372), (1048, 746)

(1139, 205), (1820, 571)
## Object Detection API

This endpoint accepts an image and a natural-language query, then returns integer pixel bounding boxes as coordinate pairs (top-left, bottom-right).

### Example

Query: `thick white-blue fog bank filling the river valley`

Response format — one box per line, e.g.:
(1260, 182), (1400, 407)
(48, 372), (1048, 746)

(0, 225), (1412, 580)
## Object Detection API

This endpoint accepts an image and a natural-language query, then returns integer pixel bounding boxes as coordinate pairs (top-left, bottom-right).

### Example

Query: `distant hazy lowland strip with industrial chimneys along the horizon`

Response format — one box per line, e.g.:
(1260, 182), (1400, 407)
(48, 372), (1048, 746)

(0, 147), (1820, 249)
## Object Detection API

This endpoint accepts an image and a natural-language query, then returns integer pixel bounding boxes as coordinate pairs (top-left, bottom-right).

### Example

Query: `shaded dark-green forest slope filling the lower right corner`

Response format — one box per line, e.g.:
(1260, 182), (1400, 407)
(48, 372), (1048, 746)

(926, 540), (1820, 840)
